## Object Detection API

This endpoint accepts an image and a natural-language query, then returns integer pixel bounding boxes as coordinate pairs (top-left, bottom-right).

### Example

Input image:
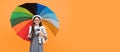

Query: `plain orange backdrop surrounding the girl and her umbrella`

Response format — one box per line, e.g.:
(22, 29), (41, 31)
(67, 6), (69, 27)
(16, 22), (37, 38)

(0, 0), (120, 52)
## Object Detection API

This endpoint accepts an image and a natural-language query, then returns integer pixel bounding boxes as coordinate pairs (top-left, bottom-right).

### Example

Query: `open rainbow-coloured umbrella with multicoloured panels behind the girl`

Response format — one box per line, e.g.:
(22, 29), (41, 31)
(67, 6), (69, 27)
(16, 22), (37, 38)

(10, 3), (59, 40)
